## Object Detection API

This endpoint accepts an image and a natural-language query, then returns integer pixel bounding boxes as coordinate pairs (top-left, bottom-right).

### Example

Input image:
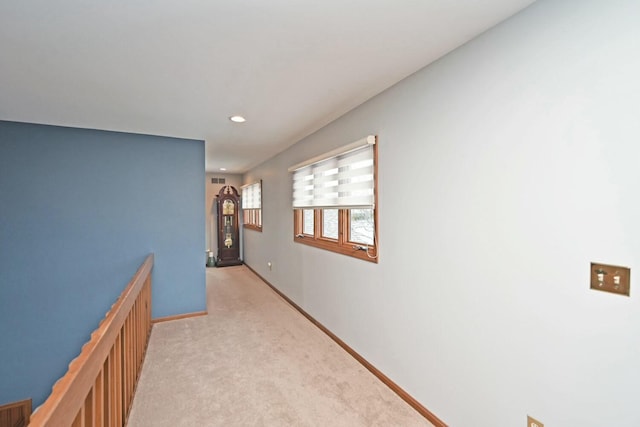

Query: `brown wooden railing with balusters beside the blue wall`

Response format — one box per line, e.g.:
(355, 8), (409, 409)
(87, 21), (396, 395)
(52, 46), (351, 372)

(29, 254), (153, 427)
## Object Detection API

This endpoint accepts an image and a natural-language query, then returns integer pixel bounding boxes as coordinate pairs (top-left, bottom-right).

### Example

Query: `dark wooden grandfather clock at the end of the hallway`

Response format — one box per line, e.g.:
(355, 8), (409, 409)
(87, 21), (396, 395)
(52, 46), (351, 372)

(216, 185), (242, 267)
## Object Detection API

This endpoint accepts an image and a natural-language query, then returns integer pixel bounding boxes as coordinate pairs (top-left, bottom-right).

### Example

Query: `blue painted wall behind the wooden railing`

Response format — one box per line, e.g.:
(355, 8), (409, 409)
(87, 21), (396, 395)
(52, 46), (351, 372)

(0, 121), (206, 405)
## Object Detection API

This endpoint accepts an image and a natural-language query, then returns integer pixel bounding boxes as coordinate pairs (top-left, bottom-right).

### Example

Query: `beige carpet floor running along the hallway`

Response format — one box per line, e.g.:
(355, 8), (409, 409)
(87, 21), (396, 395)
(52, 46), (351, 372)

(128, 266), (432, 427)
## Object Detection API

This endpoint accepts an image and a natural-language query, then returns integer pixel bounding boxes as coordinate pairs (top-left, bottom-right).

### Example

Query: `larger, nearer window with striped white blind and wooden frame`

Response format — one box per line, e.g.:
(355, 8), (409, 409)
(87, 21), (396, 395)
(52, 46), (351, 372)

(289, 137), (378, 262)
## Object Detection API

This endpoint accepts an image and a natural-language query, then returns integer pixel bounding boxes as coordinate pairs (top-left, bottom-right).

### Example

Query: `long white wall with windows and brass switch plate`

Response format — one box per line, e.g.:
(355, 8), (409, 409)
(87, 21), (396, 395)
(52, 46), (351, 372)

(244, 0), (640, 427)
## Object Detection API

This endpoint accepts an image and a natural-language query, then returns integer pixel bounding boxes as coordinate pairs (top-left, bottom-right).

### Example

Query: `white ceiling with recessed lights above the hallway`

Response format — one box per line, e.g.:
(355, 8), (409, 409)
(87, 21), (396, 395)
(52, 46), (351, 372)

(0, 0), (534, 173)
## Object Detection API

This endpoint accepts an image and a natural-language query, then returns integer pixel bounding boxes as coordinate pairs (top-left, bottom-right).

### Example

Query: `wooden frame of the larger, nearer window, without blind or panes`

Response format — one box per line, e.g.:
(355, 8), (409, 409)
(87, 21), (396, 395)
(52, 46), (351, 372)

(293, 144), (378, 264)
